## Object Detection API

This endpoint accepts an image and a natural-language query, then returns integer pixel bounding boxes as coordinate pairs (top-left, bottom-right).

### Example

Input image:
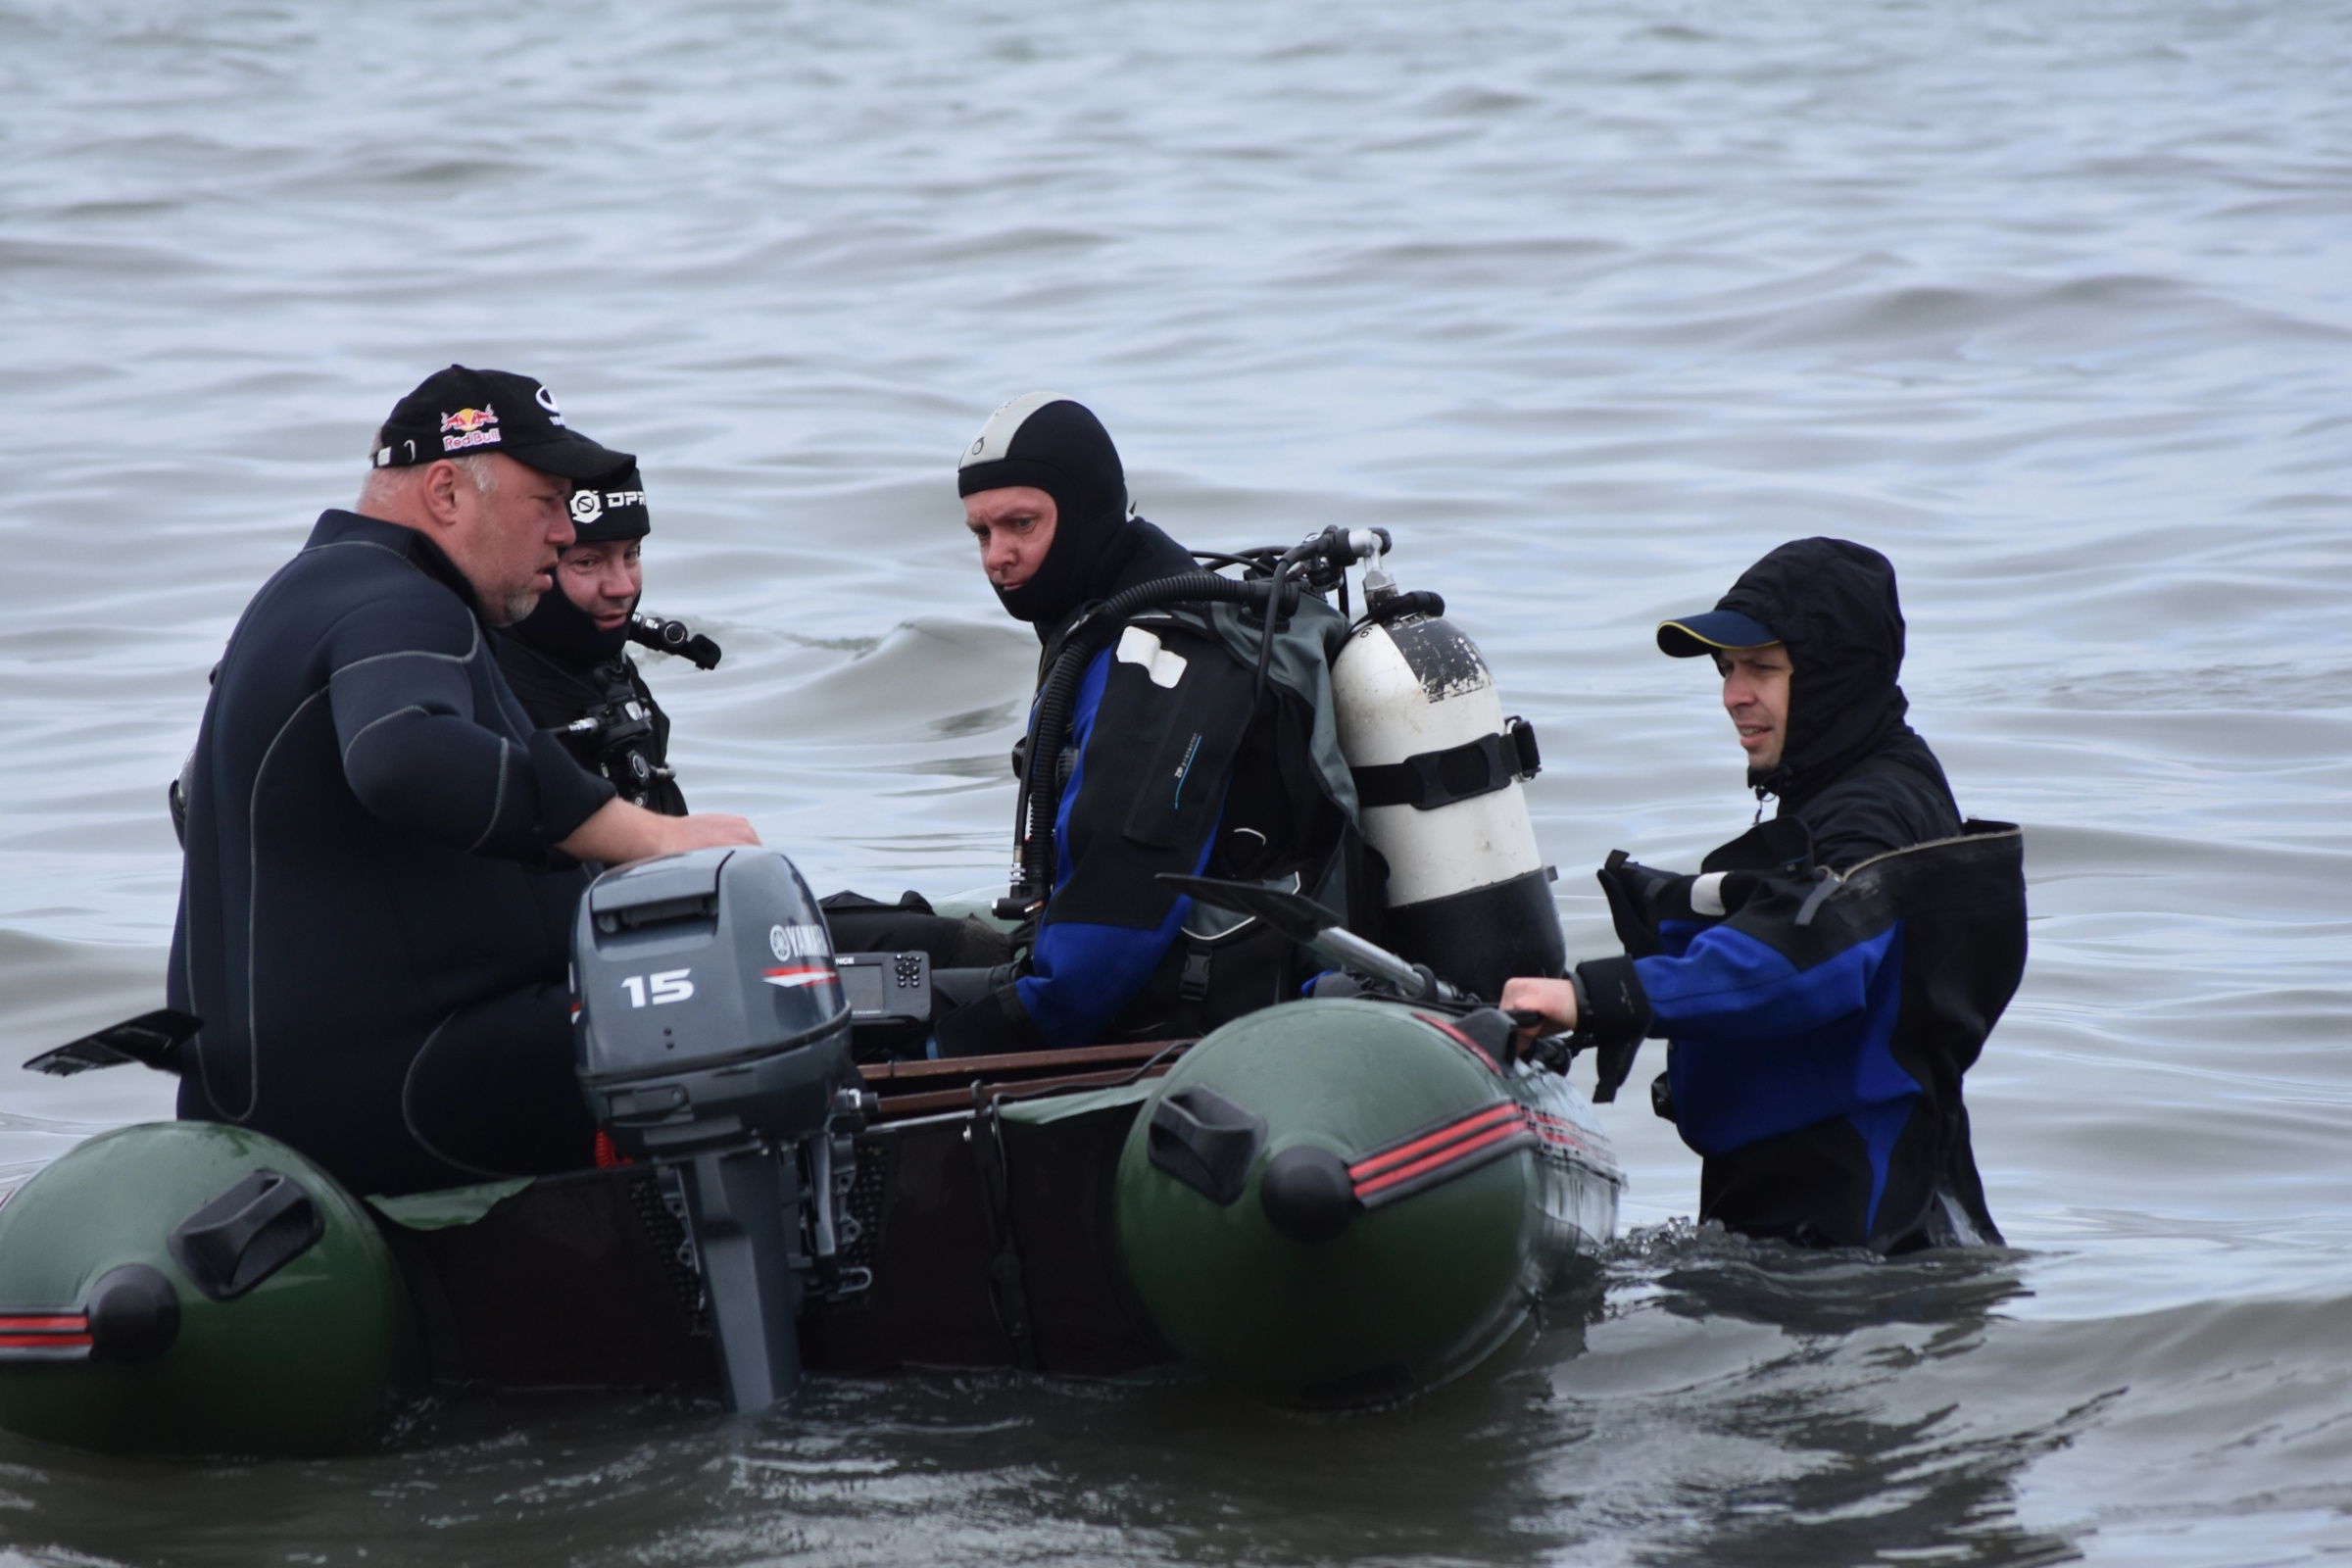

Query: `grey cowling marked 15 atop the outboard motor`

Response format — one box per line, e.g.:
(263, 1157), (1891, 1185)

(571, 849), (849, 1159)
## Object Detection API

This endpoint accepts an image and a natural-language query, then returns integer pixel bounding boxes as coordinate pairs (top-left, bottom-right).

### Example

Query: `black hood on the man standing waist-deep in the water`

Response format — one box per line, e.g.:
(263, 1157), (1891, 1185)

(1715, 538), (1940, 807)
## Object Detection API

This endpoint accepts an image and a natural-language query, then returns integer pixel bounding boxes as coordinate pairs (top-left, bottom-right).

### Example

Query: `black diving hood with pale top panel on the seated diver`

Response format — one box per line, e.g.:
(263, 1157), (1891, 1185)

(955, 393), (1143, 637)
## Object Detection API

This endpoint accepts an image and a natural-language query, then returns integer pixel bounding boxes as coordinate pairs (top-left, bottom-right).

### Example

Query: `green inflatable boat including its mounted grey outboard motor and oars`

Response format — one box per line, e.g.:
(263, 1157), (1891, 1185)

(0, 851), (1623, 1455)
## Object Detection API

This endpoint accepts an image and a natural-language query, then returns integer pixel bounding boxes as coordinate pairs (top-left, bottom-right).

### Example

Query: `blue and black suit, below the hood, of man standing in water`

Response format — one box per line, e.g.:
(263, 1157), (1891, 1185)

(1576, 818), (2025, 1253)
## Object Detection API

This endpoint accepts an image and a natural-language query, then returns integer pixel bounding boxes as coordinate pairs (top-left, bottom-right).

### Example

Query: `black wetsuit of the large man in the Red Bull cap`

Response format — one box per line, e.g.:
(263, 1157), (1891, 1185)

(170, 511), (613, 1195)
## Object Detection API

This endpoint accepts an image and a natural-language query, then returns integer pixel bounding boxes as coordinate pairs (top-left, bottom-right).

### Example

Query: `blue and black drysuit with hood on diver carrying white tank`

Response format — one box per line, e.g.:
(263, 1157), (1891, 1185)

(939, 393), (1354, 1055)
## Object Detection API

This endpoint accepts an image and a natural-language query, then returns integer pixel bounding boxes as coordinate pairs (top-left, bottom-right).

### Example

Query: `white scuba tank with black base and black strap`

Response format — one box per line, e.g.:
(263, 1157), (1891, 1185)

(1331, 553), (1566, 997)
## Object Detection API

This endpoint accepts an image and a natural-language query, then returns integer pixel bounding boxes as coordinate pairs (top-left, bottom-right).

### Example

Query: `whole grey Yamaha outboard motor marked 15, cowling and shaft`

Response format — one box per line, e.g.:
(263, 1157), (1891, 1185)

(571, 849), (860, 1410)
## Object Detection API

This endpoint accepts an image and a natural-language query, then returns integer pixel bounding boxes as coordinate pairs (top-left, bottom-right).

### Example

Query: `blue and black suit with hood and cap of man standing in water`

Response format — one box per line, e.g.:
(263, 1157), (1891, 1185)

(1576, 538), (2025, 1253)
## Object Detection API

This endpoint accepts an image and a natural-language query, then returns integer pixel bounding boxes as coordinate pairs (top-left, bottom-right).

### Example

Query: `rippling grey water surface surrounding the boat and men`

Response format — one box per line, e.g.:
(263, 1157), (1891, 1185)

(0, 0), (2352, 1566)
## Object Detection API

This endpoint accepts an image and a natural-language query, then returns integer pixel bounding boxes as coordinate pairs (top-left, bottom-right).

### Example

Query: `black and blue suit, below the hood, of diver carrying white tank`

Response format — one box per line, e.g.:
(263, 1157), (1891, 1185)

(1000, 573), (1366, 1044)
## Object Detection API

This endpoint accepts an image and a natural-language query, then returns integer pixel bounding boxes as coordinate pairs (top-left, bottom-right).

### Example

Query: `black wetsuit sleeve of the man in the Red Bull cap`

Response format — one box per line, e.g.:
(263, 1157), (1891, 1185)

(327, 590), (613, 860)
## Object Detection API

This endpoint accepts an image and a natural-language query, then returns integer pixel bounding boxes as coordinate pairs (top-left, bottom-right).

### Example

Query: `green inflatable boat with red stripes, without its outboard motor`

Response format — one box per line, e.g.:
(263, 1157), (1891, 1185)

(0, 1002), (1623, 1455)
